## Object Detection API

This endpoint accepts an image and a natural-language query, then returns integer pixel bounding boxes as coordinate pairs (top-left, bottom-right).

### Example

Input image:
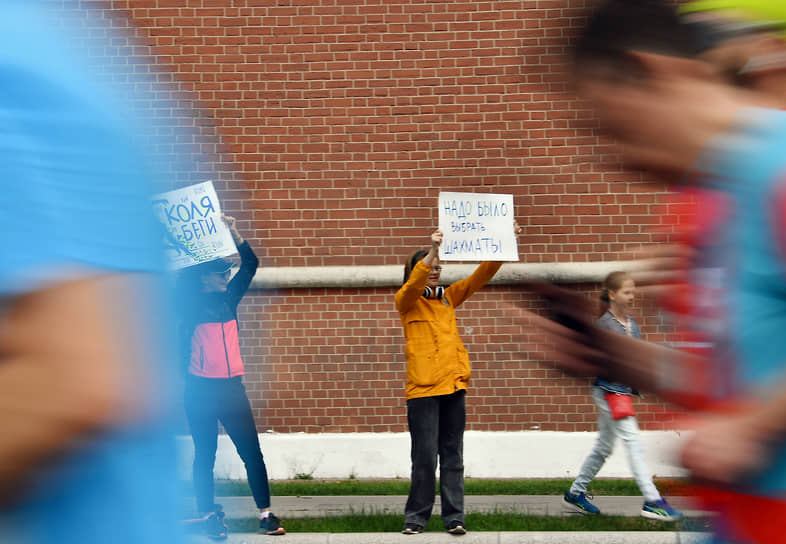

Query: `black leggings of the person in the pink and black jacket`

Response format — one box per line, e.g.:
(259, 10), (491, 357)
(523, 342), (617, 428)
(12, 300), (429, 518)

(185, 375), (270, 514)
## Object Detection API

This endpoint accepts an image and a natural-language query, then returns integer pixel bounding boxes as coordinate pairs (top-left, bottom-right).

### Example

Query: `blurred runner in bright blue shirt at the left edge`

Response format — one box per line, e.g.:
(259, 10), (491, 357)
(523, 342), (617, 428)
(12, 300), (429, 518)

(0, 0), (187, 544)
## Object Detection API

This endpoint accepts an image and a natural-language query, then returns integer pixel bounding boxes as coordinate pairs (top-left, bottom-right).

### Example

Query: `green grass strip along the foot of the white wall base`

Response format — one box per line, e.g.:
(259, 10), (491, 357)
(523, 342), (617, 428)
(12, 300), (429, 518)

(211, 478), (684, 497)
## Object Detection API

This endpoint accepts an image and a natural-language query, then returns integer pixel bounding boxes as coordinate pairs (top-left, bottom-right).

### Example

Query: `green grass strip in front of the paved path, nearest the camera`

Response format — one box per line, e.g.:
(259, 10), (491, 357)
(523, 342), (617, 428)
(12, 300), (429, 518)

(227, 512), (709, 533)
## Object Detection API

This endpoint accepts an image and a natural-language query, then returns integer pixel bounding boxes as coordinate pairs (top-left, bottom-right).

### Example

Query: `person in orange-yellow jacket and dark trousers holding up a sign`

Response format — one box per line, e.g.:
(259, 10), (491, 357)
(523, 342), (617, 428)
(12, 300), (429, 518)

(396, 224), (521, 535)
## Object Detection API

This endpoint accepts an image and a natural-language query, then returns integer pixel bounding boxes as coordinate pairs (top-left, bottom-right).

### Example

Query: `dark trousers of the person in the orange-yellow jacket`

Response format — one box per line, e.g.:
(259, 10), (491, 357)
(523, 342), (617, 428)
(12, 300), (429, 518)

(404, 391), (466, 527)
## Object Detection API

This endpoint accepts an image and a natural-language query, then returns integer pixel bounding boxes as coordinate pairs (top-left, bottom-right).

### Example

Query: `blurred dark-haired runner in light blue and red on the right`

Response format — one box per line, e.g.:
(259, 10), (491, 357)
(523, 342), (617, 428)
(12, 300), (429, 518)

(522, 0), (786, 544)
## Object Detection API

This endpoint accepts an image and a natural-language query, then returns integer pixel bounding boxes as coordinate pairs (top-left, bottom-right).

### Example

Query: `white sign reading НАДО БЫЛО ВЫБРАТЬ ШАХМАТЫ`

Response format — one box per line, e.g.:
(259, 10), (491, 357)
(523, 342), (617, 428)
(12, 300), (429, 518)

(439, 193), (519, 261)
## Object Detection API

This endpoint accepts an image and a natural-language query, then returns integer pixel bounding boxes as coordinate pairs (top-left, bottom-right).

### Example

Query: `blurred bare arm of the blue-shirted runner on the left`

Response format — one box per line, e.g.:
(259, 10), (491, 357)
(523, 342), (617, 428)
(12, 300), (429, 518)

(0, 276), (156, 499)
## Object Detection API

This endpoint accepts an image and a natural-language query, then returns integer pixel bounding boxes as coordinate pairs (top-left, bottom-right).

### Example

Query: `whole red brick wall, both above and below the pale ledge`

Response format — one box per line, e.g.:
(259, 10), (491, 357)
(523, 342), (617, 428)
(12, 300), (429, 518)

(102, 0), (672, 432)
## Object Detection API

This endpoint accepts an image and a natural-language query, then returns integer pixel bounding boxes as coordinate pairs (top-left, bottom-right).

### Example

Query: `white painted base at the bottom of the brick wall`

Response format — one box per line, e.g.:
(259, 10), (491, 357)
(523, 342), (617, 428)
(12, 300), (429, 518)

(179, 431), (688, 480)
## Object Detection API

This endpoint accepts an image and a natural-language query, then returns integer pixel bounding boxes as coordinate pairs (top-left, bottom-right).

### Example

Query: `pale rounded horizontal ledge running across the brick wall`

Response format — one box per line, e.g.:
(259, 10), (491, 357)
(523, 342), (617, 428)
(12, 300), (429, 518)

(251, 261), (644, 289)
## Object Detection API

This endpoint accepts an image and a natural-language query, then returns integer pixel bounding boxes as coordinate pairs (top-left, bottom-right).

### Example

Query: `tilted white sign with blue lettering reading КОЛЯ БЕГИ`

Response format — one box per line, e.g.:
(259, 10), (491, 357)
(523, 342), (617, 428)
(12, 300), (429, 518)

(153, 181), (237, 269)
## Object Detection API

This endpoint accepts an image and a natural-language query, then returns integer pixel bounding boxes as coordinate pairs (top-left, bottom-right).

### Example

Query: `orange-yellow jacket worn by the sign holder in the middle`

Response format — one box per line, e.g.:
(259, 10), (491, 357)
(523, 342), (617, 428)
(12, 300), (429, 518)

(396, 261), (502, 400)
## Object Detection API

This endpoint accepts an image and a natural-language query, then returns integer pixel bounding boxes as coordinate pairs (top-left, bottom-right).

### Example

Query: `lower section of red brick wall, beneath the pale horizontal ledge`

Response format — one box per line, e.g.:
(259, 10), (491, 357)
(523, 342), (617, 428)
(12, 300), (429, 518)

(240, 286), (675, 432)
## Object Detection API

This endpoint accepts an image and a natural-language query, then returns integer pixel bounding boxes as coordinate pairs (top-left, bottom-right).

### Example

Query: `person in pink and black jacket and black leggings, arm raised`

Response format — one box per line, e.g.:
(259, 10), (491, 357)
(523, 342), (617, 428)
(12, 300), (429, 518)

(181, 216), (285, 539)
